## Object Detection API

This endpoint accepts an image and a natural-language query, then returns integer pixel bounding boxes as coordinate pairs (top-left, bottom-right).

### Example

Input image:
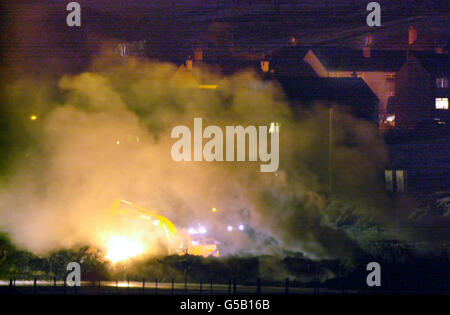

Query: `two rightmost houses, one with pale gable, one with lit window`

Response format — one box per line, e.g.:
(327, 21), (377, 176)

(271, 47), (450, 129)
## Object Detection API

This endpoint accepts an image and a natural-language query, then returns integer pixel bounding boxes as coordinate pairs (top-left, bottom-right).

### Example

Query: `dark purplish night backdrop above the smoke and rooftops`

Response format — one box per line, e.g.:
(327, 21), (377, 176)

(2, 0), (448, 71)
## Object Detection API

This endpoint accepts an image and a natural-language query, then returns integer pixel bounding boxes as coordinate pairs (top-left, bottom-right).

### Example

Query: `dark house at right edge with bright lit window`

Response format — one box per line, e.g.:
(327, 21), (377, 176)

(388, 51), (450, 129)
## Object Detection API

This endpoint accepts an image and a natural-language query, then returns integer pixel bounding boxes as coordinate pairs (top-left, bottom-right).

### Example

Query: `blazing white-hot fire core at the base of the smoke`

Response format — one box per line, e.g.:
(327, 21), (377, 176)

(106, 235), (144, 263)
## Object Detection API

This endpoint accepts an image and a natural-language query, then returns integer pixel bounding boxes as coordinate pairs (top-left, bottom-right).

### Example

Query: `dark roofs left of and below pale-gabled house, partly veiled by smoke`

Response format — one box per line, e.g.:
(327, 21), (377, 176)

(160, 45), (378, 121)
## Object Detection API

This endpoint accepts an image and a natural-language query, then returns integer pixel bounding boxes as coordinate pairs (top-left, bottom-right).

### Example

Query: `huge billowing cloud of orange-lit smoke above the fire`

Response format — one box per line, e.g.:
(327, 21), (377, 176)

(0, 51), (386, 257)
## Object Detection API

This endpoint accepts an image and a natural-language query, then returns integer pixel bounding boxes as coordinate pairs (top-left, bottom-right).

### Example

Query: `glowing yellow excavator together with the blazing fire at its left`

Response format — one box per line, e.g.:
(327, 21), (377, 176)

(101, 199), (219, 263)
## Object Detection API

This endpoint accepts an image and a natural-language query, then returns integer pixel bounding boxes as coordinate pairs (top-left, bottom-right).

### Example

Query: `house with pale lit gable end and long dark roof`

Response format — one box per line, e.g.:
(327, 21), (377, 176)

(271, 42), (407, 126)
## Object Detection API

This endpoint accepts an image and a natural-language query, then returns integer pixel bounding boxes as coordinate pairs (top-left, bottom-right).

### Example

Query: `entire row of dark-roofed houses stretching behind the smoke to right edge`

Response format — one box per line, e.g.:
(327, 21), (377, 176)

(132, 26), (444, 129)
